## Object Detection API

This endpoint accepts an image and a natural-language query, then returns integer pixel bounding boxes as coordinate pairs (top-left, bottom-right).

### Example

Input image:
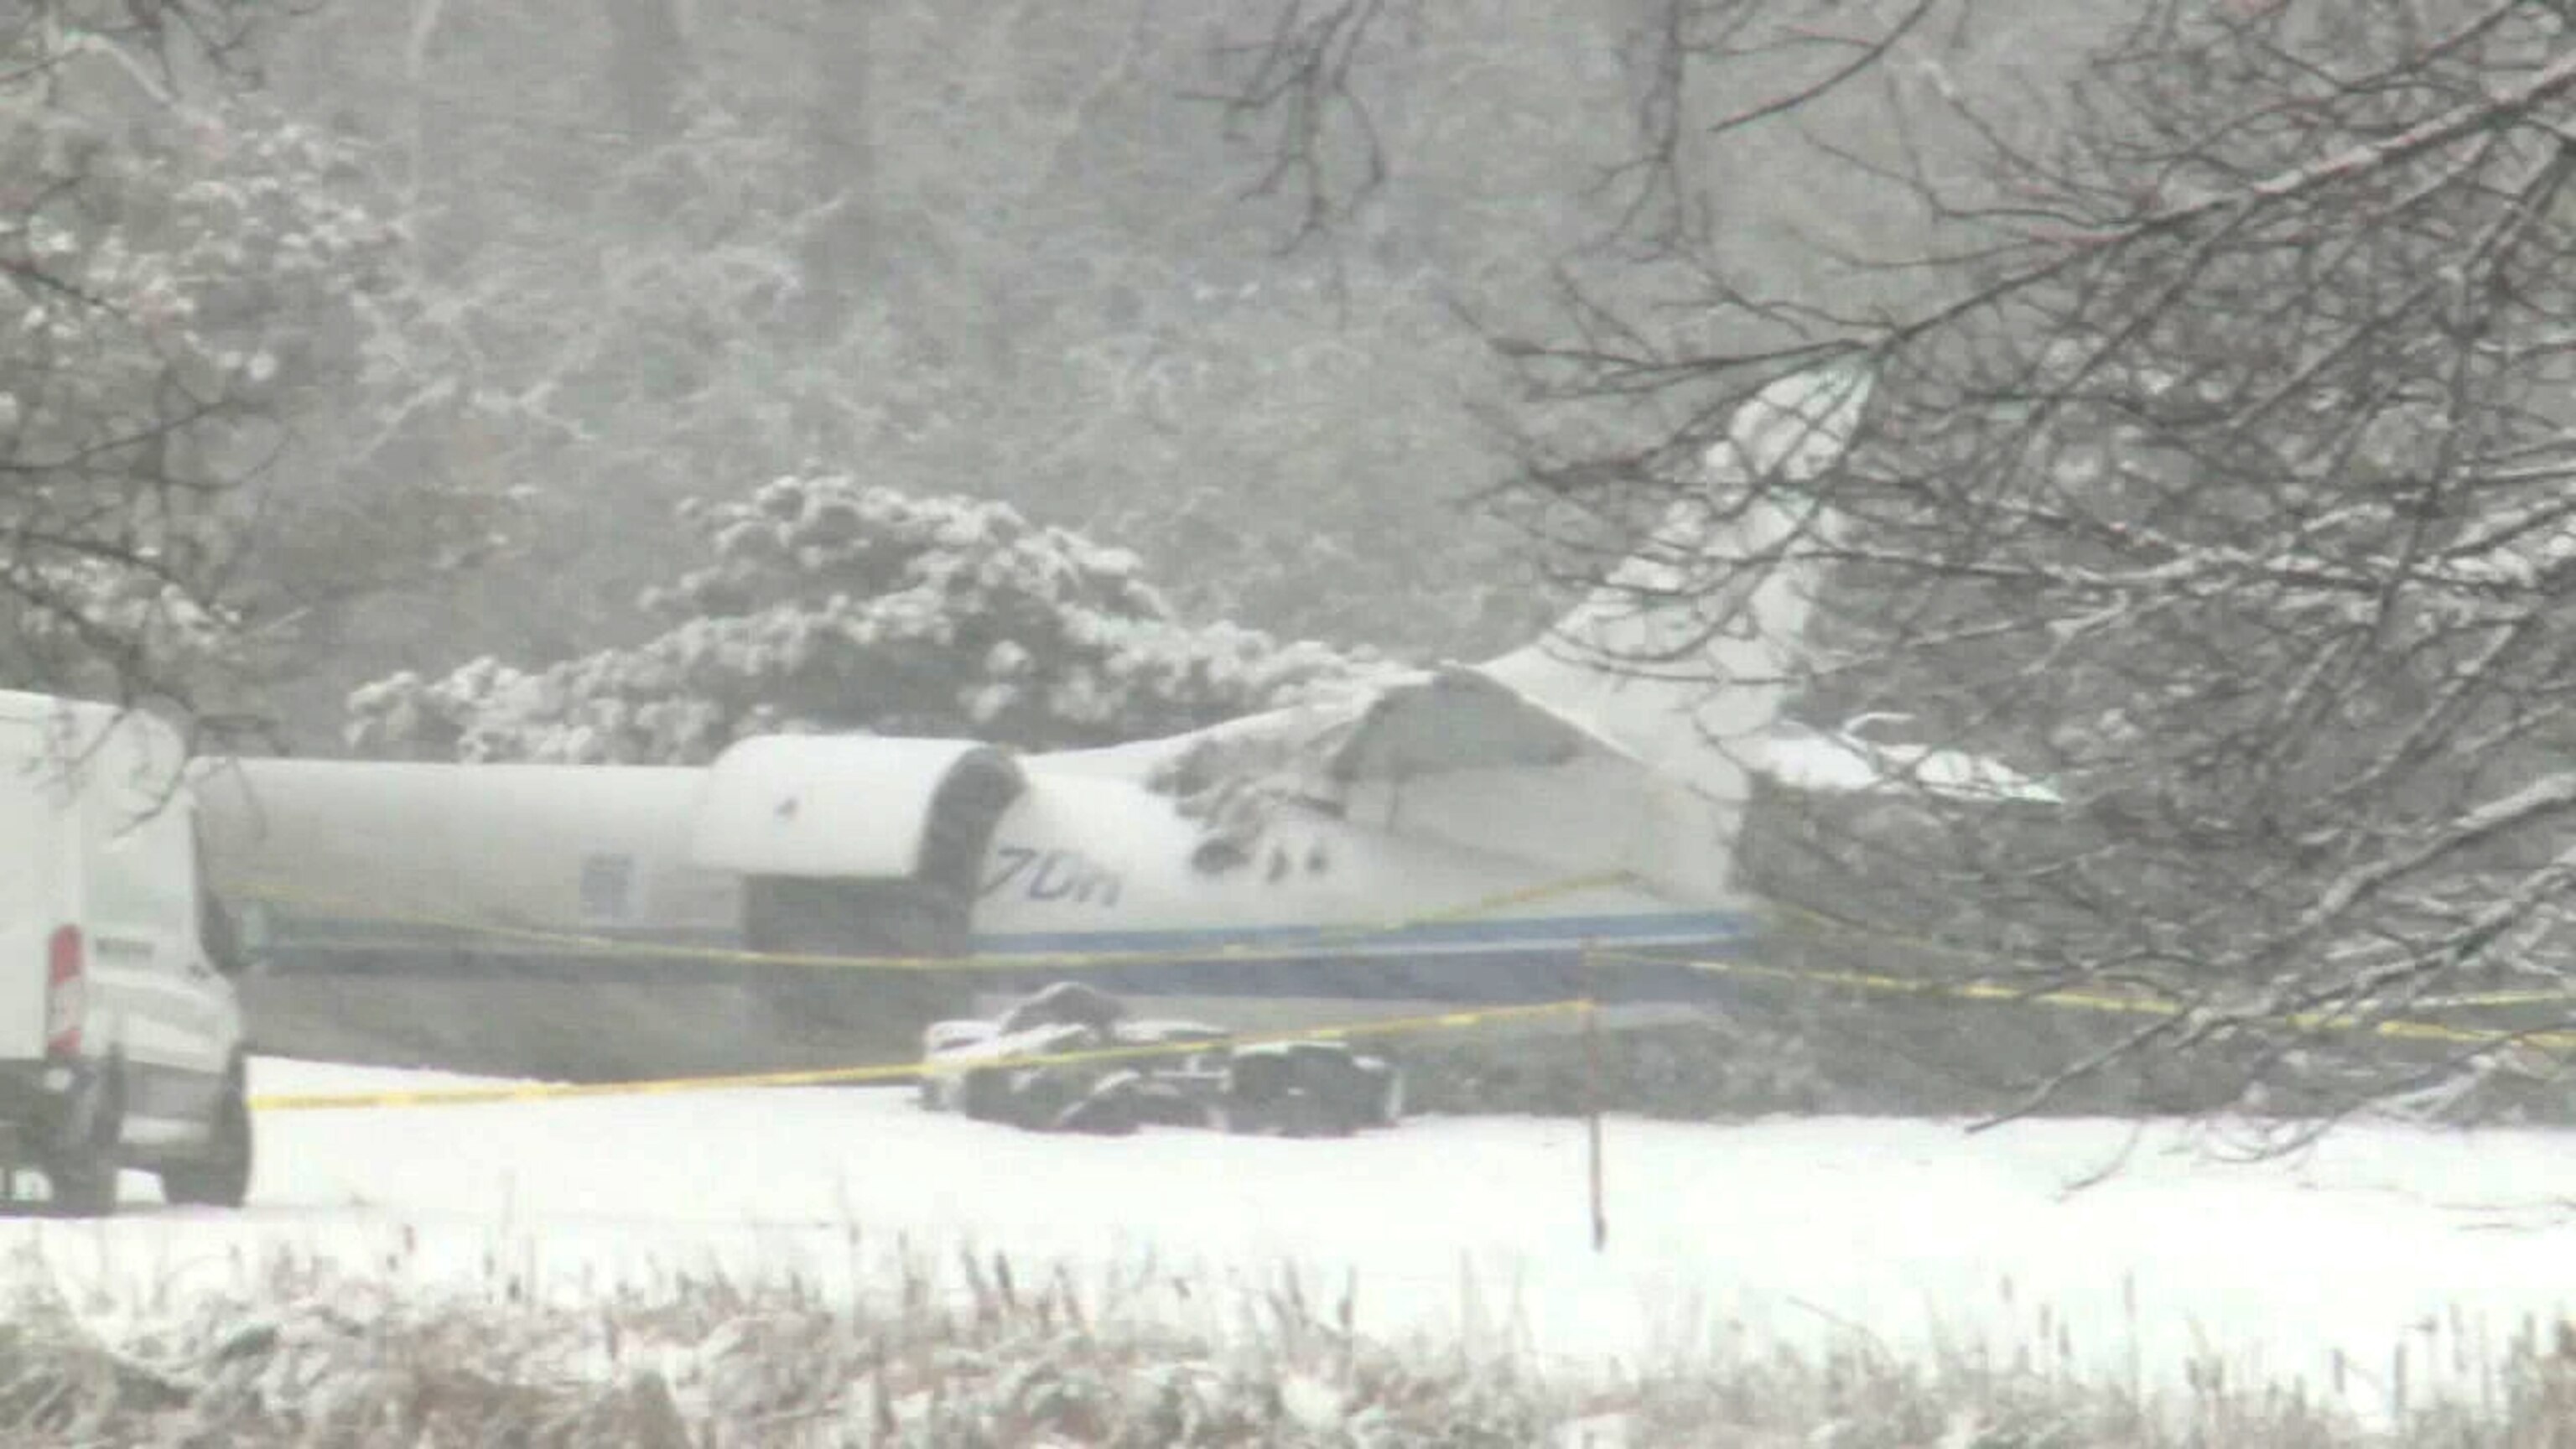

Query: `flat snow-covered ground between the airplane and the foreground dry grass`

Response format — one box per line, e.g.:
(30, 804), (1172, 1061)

(15, 1060), (2576, 1408)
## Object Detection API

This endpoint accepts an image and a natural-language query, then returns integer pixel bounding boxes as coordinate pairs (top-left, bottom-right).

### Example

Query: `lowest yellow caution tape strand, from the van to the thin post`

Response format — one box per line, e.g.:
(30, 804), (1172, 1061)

(250, 1000), (1595, 1111)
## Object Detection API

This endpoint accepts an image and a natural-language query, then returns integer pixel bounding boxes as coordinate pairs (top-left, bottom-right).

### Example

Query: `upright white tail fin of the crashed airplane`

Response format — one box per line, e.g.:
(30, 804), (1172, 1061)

(1481, 369), (1870, 802)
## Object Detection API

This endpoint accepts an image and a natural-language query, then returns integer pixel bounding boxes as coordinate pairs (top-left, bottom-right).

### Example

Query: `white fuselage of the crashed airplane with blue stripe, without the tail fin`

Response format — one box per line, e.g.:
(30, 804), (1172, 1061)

(199, 758), (1749, 1078)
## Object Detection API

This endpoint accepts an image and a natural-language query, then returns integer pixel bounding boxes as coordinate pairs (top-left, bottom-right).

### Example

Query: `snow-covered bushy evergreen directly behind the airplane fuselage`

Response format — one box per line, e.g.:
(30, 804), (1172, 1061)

(348, 475), (1375, 763)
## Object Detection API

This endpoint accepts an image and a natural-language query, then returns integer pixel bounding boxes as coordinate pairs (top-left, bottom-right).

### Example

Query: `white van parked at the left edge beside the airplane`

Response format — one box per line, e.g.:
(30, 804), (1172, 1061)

(0, 691), (250, 1214)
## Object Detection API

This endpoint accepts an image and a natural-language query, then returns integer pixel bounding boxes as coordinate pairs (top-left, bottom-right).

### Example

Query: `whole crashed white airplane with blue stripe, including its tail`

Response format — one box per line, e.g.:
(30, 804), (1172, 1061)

(201, 366), (2045, 1075)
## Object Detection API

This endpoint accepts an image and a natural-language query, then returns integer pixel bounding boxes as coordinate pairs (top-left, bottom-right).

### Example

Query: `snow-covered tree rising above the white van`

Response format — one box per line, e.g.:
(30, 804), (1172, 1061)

(0, 0), (474, 709)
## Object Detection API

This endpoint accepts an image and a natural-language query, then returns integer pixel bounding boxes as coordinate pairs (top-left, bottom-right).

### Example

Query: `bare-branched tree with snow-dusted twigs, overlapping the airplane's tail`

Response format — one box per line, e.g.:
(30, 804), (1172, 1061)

(1215, 0), (2576, 1119)
